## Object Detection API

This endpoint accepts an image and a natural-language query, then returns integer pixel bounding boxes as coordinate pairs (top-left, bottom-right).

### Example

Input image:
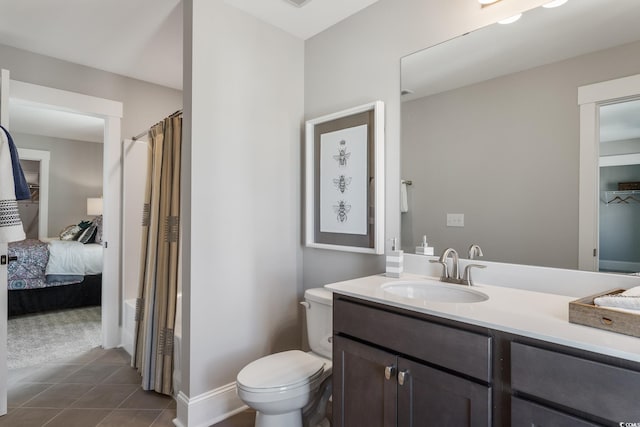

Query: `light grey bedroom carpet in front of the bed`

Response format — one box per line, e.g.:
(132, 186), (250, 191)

(7, 307), (102, 369)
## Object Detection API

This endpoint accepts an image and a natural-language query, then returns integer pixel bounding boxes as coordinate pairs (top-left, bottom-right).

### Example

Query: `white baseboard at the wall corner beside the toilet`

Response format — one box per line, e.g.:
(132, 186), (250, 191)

(173, 382), (248, 427)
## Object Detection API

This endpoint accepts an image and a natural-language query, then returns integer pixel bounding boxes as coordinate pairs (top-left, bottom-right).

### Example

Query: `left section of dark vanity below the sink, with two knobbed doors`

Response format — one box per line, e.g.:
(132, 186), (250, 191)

(333, 298), (491, 427)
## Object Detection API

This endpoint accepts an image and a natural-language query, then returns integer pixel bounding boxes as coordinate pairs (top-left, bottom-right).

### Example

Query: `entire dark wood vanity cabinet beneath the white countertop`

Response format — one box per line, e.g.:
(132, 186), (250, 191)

(333, 294), (640, 427)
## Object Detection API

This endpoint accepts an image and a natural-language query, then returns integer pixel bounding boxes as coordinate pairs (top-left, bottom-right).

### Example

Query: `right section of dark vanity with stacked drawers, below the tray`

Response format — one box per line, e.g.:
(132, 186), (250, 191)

(511, 342), (640, 427)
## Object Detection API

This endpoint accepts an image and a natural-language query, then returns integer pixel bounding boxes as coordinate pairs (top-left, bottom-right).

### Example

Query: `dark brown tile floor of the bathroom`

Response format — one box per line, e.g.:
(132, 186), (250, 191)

(0, 348), (255, 427)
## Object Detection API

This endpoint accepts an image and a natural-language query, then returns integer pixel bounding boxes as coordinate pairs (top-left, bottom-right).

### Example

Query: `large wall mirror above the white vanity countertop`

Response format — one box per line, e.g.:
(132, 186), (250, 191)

(401, 0), (640, 271)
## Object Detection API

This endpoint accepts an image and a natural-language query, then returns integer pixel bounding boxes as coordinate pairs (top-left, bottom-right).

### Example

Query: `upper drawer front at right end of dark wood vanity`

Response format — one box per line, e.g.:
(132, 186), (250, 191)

(511, 342), (640, 423)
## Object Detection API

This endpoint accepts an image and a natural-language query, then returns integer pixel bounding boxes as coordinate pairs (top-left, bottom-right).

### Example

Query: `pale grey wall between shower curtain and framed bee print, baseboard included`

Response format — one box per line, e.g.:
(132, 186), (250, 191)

(176, 0), (304, 426)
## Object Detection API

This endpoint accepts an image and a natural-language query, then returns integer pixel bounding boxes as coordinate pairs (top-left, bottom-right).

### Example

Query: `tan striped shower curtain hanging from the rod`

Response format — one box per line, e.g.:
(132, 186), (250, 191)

(131, 113), (182, 395)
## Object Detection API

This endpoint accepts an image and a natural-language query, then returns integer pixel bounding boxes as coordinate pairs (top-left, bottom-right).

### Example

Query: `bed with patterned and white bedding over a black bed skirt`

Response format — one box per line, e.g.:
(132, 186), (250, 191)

(8, 239), (102, 317)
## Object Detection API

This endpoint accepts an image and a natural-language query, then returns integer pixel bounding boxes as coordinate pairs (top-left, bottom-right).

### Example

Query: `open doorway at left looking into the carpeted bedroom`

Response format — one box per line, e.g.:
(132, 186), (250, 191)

(7, 127), (104, 368)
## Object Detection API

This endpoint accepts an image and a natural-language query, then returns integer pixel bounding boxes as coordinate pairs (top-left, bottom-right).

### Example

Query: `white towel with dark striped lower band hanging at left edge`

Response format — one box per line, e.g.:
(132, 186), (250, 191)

(0, 132), (26, 243)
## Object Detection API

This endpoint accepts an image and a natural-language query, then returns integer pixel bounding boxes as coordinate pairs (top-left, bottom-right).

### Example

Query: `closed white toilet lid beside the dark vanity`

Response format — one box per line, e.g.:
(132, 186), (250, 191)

(237, 350), (324, 391)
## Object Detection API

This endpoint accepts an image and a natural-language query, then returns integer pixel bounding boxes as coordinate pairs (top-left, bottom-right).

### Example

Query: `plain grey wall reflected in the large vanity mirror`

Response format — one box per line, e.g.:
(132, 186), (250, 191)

(401, 39), (640, 268)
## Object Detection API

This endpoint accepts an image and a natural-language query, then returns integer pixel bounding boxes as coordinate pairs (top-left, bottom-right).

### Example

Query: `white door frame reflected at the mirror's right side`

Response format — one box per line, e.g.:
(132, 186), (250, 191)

(578, 74), (640, 271)
